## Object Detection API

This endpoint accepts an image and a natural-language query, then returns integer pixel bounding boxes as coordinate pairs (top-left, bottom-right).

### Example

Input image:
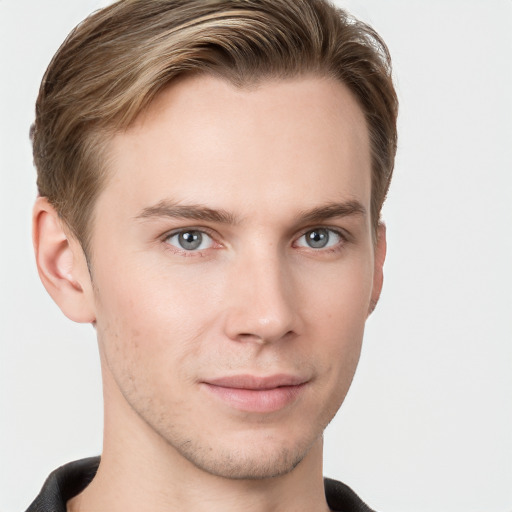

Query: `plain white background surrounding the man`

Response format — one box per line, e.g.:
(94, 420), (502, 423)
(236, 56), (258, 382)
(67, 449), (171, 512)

(0, 0), (512, 512)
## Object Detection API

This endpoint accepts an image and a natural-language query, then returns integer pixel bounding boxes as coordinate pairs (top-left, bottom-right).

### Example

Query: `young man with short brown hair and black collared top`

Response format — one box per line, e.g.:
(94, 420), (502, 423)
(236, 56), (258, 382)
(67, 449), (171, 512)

(29, 0), (397, 512)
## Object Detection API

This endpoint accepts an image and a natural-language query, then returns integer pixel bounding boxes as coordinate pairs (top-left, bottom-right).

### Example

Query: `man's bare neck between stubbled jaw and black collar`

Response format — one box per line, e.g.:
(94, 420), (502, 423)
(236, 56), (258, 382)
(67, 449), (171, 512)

(68, 364), (328, 512)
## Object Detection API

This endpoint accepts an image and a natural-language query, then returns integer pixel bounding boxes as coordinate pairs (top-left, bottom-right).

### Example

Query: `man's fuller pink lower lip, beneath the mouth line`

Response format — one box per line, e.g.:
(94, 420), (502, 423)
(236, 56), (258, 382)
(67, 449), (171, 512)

(203, 383), (305, 413)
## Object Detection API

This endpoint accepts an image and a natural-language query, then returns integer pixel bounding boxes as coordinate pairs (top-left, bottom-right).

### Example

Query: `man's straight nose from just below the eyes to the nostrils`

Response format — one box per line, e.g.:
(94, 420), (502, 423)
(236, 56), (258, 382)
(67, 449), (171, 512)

(224, 251), (300, 344)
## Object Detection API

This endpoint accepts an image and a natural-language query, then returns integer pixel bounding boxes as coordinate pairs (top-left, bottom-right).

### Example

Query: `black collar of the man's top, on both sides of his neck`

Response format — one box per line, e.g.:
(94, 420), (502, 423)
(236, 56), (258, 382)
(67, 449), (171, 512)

(26, 457), (374, 512)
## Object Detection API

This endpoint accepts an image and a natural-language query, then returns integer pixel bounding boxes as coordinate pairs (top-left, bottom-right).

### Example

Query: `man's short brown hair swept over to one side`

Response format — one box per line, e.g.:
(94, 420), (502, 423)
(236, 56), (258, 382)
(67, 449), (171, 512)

(31, 0), (398, 253)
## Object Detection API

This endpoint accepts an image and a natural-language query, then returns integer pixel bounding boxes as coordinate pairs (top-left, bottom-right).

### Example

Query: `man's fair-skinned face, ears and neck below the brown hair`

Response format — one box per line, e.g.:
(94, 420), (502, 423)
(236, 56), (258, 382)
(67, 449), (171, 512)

(34, 76), (385, 512)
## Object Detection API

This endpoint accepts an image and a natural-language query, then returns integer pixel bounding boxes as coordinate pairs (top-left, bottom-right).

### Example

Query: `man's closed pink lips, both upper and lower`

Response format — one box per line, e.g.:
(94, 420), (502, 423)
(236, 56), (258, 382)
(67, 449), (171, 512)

(202, 374), (308, 413)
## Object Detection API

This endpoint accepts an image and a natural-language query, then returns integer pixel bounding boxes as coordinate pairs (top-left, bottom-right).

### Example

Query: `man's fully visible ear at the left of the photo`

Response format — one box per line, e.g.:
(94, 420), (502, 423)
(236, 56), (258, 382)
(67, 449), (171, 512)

(32, 197), (96, 323)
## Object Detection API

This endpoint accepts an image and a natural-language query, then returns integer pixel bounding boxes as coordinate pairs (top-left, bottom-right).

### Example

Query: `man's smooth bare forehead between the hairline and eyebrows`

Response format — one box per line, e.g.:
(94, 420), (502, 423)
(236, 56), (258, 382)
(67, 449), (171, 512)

(99, 76), (371, 220)
